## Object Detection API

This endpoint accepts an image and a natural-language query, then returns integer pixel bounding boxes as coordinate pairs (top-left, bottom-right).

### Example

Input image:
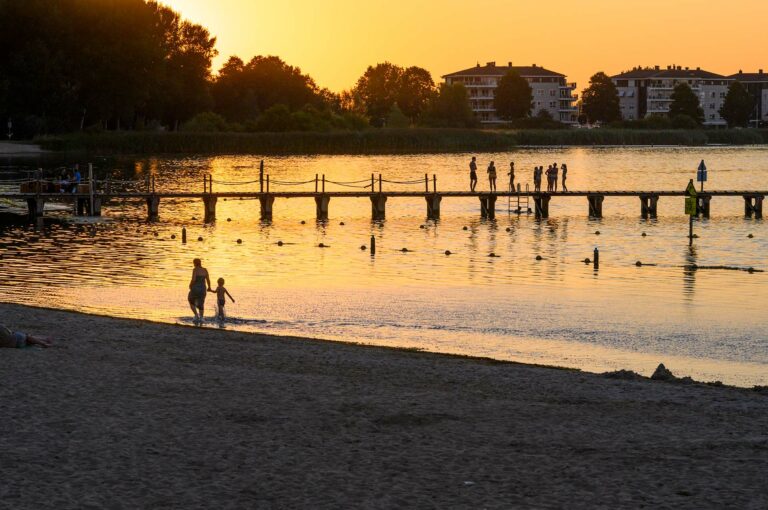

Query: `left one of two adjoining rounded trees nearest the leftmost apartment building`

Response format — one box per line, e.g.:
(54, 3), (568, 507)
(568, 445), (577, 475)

(355, 62), (403, 127)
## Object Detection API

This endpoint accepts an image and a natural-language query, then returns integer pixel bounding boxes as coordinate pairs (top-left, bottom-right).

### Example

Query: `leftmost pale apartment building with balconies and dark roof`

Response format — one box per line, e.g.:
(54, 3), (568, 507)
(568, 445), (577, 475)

(443, 62), (579, 124)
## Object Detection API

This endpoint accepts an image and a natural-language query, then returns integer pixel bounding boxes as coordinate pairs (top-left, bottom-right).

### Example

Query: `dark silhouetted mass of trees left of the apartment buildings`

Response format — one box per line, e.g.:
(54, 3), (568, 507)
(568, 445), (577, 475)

(0, 0), (475, 139)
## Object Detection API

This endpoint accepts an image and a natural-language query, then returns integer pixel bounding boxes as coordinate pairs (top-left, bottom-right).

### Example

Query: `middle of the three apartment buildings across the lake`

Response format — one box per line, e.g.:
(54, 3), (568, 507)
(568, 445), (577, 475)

(611, 66), (733, 126)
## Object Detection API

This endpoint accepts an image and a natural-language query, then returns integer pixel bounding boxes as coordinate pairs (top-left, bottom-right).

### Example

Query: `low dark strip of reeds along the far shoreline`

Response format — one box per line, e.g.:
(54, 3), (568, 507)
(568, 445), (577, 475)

(36, 128), (768, 155)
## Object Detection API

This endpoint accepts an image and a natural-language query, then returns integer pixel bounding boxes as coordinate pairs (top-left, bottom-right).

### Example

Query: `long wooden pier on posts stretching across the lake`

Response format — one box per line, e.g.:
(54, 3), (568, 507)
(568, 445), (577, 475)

(0, 175), (768, 222)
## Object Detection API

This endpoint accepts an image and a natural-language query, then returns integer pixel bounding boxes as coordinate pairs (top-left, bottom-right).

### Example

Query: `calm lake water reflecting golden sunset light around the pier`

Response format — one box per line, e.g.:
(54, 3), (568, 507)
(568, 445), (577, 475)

(0, 147), (768, 385)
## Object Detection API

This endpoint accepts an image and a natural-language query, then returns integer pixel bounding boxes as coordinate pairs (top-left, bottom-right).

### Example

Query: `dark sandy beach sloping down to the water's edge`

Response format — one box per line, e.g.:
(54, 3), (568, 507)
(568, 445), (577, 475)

(0, 305), (768, 509)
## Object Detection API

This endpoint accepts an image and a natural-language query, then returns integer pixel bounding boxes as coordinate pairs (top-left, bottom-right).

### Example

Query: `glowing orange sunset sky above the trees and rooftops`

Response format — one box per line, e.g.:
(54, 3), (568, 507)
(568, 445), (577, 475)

(163, 0), (768, 91)
